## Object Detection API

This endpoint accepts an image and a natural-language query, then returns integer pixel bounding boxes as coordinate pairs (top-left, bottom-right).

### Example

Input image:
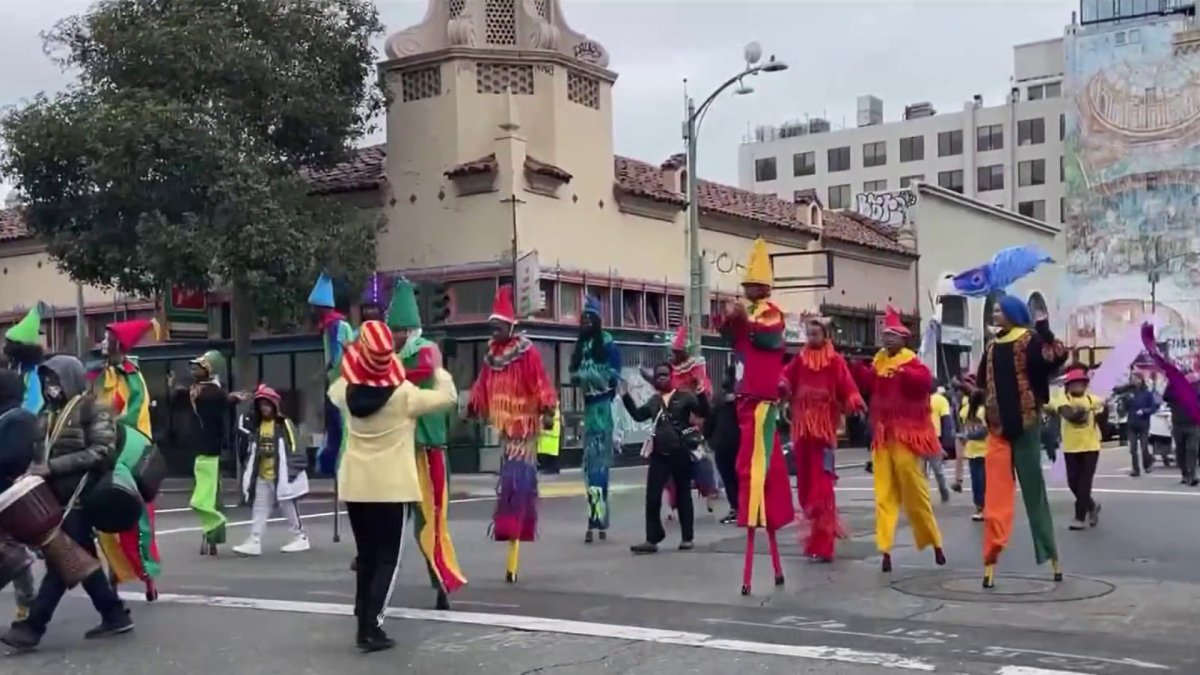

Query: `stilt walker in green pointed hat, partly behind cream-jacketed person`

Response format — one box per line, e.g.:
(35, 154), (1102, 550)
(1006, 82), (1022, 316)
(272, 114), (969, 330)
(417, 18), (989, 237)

(388, 279), (467, 609)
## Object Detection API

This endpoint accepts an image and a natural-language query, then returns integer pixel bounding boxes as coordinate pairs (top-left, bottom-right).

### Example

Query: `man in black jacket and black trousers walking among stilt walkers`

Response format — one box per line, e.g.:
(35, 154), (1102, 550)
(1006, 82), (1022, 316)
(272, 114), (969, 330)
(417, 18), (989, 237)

(620, 364), (706, 554)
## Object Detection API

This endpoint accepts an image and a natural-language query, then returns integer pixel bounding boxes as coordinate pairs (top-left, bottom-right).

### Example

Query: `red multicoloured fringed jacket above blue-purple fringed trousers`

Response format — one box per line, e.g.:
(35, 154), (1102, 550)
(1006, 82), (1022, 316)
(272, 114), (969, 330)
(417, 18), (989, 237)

(468, 335), (558, 438)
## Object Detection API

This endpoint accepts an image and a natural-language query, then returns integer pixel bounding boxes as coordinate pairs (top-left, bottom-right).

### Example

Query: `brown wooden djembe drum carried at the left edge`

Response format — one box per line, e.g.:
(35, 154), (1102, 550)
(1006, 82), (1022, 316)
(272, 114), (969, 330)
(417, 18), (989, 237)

(0, 476), (100, 589)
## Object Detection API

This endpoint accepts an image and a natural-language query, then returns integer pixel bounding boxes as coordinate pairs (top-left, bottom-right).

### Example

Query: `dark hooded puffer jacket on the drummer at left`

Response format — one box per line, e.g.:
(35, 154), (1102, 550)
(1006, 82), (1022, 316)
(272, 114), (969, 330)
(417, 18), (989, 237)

(41, 356), (118, 506)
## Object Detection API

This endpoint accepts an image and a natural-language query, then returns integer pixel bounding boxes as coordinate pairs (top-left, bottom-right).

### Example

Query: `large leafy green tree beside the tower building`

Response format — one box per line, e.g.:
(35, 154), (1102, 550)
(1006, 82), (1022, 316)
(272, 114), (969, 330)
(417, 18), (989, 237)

(0, 0), (385, 387)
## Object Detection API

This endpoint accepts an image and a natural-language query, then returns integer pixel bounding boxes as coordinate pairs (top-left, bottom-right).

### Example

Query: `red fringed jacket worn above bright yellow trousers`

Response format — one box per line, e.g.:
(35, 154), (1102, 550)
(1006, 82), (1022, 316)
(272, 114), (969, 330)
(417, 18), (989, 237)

(871, 350), (942, 458)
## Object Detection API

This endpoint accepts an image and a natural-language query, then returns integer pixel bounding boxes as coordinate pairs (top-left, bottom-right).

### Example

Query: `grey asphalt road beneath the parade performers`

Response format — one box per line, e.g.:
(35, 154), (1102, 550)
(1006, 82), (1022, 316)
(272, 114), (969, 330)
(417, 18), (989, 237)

(7, 441), (1200, 675)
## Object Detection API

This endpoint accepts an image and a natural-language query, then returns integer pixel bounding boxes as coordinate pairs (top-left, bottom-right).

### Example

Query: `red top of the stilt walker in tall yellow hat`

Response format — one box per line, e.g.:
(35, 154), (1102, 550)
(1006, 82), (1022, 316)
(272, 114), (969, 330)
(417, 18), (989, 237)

(718, 300), (785, 401)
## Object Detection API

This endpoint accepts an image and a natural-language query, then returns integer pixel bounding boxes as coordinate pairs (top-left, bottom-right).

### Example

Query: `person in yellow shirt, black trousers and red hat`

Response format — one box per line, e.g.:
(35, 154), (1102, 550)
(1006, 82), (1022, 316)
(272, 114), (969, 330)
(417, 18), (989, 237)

(1050, 365), (1104, 530)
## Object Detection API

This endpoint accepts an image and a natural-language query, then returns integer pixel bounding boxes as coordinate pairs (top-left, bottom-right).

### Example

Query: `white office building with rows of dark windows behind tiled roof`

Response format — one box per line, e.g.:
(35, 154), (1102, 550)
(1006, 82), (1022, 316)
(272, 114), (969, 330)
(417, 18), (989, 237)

(738, 37), (1066, 225)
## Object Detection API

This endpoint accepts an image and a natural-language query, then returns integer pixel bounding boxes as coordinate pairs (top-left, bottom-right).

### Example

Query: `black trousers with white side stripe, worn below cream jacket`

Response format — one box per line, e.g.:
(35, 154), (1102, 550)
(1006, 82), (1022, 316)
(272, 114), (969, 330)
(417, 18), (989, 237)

(346, 502), (407, 631)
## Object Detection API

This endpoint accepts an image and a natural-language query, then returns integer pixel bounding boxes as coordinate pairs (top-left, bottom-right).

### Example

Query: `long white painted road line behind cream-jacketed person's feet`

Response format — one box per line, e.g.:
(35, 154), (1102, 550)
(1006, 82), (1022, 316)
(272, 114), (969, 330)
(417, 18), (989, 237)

(121, 593), (940, 675)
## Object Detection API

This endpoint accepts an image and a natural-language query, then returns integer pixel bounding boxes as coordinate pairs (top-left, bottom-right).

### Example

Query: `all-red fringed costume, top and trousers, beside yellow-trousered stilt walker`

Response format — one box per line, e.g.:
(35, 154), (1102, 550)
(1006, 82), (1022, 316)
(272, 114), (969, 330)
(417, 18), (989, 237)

(784, 340), (865, 562)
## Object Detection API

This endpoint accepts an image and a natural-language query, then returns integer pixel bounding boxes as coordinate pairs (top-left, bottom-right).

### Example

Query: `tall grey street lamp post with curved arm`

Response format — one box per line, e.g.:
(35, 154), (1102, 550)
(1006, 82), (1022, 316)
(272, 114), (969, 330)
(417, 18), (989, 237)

(683, 42), (787, 354)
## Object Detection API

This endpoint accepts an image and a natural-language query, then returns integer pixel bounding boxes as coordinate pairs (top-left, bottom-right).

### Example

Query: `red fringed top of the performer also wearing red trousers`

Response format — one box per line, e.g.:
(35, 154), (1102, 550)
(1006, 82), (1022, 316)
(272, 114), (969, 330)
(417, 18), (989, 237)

(782, 342), (864, 447)
